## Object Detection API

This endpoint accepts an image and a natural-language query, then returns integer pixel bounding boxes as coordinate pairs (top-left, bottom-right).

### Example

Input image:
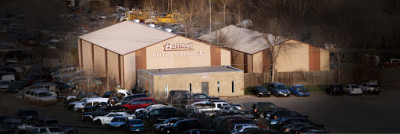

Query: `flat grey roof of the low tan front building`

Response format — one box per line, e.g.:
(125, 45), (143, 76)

(141, 66), (242, 75)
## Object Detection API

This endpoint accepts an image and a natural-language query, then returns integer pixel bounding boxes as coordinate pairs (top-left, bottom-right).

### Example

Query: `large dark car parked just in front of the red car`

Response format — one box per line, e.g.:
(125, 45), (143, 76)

(137, 107), (186, 126)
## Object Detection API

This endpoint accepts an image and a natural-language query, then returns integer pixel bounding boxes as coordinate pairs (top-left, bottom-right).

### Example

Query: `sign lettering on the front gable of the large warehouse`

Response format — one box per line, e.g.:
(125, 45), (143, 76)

(153, 42), (204, 57)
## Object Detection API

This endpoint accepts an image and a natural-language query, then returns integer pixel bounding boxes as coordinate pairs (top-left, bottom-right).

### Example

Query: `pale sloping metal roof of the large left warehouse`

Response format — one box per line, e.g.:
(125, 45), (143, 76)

(79, 21), (177, 55)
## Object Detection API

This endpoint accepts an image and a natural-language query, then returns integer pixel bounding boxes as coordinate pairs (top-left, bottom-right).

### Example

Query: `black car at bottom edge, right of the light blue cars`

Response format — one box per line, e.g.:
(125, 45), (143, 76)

(164, 119), (203, 134)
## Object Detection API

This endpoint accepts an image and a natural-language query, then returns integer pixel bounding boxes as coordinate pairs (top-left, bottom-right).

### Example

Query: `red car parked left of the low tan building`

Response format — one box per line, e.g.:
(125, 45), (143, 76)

(122, 98), (156, 111)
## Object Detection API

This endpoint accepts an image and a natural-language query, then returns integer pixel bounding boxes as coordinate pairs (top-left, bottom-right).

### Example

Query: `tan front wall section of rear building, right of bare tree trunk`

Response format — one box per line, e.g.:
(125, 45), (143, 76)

(275, 40), (309, 72)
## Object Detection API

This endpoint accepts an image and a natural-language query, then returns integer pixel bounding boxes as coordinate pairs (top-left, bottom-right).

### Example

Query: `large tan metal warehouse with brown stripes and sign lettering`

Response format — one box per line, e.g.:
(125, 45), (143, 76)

(78, 21), (244, 95)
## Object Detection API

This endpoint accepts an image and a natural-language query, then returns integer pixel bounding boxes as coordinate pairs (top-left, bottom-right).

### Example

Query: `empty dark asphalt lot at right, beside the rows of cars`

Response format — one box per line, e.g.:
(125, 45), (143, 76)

(227, 90), (400, 133)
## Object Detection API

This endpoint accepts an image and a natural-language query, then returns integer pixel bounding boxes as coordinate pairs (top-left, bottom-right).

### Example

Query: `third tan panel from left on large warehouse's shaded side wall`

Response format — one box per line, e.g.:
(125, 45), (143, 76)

(107, 50), (121, 82)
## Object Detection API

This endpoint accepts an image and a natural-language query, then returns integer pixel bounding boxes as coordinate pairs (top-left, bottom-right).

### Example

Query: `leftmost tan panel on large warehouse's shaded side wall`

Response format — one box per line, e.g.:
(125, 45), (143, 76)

(82, 40), (93, 73)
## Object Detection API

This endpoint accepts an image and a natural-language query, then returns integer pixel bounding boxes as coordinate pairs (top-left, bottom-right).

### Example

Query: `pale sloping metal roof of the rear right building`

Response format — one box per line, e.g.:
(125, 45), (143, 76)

(198, 25), (288, 54)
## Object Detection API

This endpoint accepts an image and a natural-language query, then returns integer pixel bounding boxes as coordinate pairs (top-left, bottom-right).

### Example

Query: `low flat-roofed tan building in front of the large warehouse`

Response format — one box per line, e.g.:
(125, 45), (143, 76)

(137, 66), (244, 100)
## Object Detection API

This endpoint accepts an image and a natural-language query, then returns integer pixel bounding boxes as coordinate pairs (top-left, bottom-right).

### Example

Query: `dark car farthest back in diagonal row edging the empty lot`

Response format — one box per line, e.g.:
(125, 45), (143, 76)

(251, 102), (278, 118)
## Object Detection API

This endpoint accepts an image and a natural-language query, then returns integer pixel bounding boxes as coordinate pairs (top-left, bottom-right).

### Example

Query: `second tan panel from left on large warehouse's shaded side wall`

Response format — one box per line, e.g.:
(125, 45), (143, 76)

(93, 45), (106, 77)
